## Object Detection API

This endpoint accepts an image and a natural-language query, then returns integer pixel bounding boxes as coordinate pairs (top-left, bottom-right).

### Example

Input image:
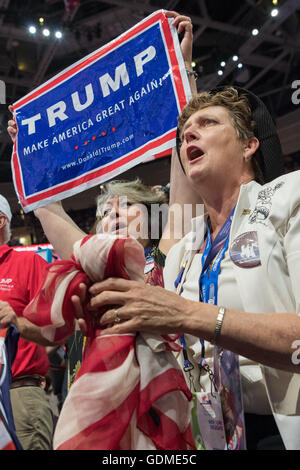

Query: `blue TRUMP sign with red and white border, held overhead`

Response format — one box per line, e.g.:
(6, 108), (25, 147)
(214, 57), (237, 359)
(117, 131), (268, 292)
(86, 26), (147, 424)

(12, 10), (191, 212)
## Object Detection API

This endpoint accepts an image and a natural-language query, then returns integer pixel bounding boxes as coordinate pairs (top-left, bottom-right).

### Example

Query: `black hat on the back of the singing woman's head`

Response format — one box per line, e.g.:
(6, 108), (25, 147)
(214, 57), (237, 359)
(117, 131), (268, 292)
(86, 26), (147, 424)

(176, 86), (284, 183)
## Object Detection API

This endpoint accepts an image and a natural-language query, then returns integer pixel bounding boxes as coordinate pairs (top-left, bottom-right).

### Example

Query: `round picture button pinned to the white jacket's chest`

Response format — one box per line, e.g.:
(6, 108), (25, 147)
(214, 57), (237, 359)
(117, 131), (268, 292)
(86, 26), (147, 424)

(229, 232), (261, 268)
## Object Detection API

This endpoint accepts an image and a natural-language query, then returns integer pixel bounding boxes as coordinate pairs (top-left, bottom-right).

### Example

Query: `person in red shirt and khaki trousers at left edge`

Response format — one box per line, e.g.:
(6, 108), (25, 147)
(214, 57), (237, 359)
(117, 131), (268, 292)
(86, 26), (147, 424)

(0, 195), (53, 450)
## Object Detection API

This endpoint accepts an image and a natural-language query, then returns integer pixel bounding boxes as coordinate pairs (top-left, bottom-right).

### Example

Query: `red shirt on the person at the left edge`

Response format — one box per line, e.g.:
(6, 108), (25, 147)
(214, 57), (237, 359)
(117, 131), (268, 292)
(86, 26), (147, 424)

(0, 245), (49, 377)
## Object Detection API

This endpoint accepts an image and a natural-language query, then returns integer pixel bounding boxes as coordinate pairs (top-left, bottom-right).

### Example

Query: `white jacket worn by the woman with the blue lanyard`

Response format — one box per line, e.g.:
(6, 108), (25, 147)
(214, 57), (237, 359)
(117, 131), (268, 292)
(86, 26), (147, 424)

(164, 171), (300, 449)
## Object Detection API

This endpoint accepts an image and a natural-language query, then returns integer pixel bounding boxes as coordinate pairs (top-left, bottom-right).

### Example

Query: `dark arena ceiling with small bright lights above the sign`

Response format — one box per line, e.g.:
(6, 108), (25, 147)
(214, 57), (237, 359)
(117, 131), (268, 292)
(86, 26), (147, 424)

(0, 0), (300, 186)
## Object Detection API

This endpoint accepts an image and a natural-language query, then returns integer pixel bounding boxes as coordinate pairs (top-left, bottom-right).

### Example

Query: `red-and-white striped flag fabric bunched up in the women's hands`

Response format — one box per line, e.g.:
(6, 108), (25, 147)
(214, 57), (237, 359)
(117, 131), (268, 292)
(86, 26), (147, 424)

(24, 234), (195, 450)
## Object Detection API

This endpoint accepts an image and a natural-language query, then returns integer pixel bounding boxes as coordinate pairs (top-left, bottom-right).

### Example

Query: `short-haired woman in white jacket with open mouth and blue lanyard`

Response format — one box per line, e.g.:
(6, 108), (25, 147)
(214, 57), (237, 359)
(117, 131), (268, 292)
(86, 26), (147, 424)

(86, 88), (300, 449)
